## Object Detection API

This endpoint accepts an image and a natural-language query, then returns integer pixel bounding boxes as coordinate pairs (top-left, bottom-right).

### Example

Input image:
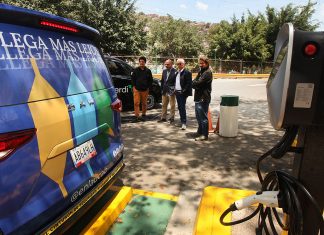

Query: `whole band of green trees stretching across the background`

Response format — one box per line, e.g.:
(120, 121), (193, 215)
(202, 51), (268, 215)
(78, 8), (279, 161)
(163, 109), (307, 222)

(2, 0), (318, 61)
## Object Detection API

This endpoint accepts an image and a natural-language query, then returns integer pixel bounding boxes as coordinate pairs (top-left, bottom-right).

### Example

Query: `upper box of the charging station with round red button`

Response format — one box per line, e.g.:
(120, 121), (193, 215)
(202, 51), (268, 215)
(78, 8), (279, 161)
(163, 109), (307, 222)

(267, 23), (324, 130)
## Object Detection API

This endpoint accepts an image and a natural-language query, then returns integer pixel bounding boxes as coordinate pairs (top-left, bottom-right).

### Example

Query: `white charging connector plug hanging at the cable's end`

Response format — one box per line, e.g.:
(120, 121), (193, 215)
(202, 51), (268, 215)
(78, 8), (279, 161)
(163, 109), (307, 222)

(234, 191), (279, 210)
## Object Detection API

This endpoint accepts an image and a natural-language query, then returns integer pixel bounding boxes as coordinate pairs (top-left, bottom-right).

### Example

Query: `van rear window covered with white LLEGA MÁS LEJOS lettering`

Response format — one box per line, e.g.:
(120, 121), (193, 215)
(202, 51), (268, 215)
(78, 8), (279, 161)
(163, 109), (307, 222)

(0, 23), (117, 106)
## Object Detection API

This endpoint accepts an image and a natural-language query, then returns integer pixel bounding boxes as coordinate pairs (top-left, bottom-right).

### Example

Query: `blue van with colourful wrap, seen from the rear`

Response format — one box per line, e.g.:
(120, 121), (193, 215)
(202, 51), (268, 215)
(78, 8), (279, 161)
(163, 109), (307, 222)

(0, 4), (124, 234)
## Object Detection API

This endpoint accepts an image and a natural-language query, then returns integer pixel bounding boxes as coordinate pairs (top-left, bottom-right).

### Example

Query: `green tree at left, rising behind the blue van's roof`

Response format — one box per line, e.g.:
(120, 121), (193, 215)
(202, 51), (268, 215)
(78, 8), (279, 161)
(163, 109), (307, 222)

(2, 0), (146, 55)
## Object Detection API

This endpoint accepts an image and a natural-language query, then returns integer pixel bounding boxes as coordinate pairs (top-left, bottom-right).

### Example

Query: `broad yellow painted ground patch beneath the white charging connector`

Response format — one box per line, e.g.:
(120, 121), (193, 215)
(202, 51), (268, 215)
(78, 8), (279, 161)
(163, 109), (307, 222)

(194, 186), (255, 235)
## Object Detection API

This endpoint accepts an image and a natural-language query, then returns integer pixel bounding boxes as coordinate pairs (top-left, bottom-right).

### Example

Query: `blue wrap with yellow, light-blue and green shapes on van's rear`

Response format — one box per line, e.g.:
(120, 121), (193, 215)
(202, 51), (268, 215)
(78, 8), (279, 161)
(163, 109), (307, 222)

(0, 11), (121, 234)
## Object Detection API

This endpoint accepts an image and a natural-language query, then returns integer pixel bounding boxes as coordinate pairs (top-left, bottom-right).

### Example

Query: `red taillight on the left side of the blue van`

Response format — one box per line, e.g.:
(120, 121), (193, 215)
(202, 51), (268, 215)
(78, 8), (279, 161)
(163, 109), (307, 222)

(0, 129), (36, 161)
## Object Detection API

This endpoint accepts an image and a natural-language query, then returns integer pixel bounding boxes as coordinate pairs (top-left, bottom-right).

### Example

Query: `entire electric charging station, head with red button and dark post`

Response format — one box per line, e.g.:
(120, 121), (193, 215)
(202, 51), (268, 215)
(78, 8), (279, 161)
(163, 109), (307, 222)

(267, 23), (324, 235)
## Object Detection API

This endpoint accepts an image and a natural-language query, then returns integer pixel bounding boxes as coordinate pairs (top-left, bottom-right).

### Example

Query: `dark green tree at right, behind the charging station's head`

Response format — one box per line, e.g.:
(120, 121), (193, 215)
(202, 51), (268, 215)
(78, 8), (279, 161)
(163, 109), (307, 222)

(208, 1), (318, 61)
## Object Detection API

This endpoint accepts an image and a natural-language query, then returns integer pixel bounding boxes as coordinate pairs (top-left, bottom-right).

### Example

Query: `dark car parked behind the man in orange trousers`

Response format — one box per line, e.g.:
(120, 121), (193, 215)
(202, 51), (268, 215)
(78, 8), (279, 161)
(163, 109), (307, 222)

(105, 55), (162, 109)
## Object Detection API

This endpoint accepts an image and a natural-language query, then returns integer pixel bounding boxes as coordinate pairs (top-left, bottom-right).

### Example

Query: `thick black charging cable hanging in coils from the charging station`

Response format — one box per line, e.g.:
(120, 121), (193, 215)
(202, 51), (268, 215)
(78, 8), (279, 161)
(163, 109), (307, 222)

(220, 126), (324, 235)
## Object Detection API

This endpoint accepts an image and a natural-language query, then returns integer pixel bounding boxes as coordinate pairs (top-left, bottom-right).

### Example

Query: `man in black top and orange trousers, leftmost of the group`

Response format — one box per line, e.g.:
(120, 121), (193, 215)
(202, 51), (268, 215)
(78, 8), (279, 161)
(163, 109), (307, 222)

(132, 56), (153, 121)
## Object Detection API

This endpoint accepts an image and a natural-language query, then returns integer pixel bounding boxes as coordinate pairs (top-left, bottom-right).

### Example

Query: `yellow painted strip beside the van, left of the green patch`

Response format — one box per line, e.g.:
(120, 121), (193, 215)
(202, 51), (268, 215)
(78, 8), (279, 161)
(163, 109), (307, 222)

(82, 186), (133, 235)
